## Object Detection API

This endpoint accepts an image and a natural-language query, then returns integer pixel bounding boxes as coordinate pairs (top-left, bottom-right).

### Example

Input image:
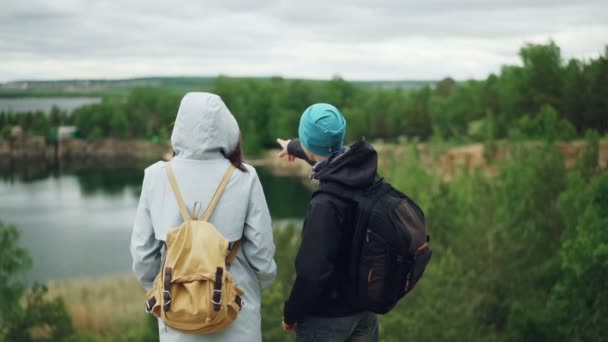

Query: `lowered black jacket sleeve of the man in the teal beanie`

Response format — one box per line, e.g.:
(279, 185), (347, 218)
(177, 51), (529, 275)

(283, 202), (341, 324)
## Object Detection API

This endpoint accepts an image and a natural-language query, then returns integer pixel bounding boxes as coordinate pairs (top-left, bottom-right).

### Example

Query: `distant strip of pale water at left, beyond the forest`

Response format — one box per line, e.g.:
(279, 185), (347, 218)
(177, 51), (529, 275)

(0, 97), (101, 113)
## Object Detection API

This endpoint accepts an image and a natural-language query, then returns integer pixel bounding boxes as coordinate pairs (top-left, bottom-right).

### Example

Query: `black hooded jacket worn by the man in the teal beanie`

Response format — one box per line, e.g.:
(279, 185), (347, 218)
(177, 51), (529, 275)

(283, 138), (378, 324)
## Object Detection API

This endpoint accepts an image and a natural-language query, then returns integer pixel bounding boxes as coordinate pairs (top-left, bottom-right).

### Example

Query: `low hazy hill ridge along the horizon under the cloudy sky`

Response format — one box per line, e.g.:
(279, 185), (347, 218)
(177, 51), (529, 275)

(0, 77), (437, 97)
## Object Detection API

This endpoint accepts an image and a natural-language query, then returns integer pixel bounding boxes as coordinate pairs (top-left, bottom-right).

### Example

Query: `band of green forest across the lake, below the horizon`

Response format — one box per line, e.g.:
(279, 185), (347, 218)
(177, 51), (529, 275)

(0, 42), (608, 155)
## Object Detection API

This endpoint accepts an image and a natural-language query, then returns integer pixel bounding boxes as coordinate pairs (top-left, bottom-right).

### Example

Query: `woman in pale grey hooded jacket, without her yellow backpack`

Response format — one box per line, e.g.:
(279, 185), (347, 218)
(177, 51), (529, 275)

(131, 93), (276, 341)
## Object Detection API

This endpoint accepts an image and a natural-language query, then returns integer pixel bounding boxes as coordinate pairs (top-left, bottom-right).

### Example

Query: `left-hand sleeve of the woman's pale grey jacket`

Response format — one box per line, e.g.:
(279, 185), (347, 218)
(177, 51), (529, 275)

(131, 170), (162, 291)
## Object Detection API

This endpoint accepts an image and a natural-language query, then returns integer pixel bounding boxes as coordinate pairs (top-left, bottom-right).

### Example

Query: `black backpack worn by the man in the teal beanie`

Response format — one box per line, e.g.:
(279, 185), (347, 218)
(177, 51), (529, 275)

(319, 178), (432, 314)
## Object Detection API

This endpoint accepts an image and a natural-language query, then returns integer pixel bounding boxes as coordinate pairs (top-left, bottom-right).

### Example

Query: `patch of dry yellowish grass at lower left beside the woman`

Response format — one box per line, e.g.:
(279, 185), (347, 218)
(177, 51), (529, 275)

(48, 275), (147, 337)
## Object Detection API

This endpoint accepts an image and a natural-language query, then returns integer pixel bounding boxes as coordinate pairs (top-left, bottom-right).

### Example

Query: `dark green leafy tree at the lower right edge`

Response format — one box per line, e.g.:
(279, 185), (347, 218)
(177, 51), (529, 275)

(548, 173), (608, 341)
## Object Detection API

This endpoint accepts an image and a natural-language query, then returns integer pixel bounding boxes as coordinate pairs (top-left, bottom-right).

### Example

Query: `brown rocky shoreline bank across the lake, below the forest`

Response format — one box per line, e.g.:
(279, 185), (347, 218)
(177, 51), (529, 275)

(0, 137), (608, 182)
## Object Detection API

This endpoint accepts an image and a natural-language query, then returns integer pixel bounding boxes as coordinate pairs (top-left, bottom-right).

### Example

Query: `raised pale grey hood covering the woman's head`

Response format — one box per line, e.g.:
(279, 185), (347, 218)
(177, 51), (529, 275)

(171, 93), (240, 159)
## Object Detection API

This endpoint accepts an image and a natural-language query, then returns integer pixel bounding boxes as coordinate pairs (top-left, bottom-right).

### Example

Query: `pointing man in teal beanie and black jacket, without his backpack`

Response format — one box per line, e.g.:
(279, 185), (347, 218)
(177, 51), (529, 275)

(277, 103), (378, 341)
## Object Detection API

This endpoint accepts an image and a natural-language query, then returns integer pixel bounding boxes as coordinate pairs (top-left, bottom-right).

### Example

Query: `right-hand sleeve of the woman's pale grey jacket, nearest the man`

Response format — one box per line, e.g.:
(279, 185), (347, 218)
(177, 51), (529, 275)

(242, 168), (277, 289)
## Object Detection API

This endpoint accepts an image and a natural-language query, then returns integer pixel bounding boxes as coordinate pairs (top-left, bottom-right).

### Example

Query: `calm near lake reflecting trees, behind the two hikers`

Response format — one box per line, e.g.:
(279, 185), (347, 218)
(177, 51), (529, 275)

(0, 165), (311, 282)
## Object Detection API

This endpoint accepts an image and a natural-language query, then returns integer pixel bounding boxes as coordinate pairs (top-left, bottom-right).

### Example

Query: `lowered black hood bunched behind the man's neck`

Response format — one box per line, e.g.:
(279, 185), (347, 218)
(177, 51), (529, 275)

(314, 138), (378, 189)
